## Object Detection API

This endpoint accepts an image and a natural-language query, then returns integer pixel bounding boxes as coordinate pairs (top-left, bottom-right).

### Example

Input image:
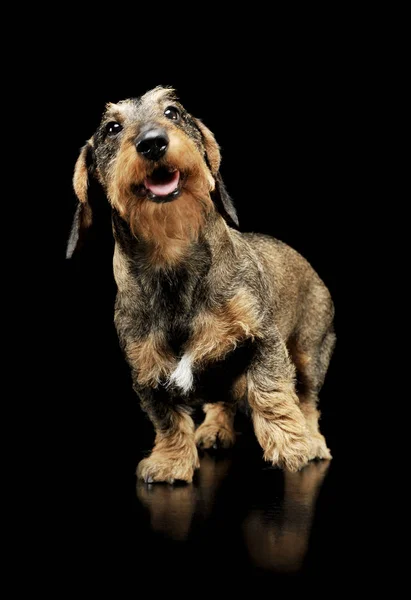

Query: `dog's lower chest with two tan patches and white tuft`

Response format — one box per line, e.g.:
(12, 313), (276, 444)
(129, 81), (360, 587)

(126, 291), (259, 394)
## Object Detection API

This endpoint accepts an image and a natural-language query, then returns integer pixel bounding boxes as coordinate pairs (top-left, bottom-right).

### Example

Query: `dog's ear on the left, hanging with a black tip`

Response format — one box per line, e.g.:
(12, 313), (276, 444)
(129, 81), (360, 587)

(66, 141), (94, 258)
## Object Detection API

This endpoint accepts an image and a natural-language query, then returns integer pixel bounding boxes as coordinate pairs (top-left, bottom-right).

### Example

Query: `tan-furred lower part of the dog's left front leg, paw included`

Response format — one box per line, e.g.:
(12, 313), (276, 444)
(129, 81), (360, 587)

(137, 411), (200, 483)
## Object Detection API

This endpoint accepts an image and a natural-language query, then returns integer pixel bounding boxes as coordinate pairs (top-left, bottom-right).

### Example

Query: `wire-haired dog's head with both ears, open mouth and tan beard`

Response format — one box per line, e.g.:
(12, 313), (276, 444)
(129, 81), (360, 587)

(67, 87), (238, 257)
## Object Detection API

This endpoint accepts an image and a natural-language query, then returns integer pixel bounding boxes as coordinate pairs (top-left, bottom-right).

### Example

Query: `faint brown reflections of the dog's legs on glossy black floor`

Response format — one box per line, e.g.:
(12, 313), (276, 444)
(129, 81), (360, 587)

(137, 454), (330, 572)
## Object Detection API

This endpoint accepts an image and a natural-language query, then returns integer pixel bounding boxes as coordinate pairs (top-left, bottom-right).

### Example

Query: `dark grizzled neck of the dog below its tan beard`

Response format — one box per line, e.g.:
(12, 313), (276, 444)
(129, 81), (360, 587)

(113, 212), (236, 355)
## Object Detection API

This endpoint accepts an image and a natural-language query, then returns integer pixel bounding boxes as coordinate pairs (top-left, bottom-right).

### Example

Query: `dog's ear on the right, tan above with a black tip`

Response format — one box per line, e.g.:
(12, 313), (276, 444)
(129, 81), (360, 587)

(196, 119), (239, 227)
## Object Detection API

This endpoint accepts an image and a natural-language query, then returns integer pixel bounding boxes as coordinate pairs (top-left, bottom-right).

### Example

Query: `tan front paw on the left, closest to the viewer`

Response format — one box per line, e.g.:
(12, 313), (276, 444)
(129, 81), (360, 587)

(137, 448), (200, 483)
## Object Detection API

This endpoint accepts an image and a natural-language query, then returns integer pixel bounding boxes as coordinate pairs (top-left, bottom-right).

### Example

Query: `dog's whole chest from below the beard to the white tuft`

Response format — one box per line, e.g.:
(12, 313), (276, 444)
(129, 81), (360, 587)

(114, 245), (260, 394)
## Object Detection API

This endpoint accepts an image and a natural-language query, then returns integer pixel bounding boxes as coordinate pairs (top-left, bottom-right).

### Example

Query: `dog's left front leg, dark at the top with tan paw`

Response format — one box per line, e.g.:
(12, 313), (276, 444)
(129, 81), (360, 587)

(137, 389), (200, 483)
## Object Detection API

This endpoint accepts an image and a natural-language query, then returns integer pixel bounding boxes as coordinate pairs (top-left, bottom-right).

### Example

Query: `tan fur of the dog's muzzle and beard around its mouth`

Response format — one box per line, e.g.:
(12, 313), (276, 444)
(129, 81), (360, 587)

(108, 125), (215, 266)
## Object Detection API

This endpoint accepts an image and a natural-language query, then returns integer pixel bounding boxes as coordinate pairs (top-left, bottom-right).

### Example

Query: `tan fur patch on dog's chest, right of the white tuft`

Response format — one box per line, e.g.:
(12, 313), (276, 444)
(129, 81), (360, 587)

(189, 290), (259, 363)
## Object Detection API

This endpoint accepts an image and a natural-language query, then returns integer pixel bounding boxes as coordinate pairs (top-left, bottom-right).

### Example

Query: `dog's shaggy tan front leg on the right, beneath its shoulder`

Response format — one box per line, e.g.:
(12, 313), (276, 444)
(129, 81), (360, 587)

(247, 332), (310, 471)
